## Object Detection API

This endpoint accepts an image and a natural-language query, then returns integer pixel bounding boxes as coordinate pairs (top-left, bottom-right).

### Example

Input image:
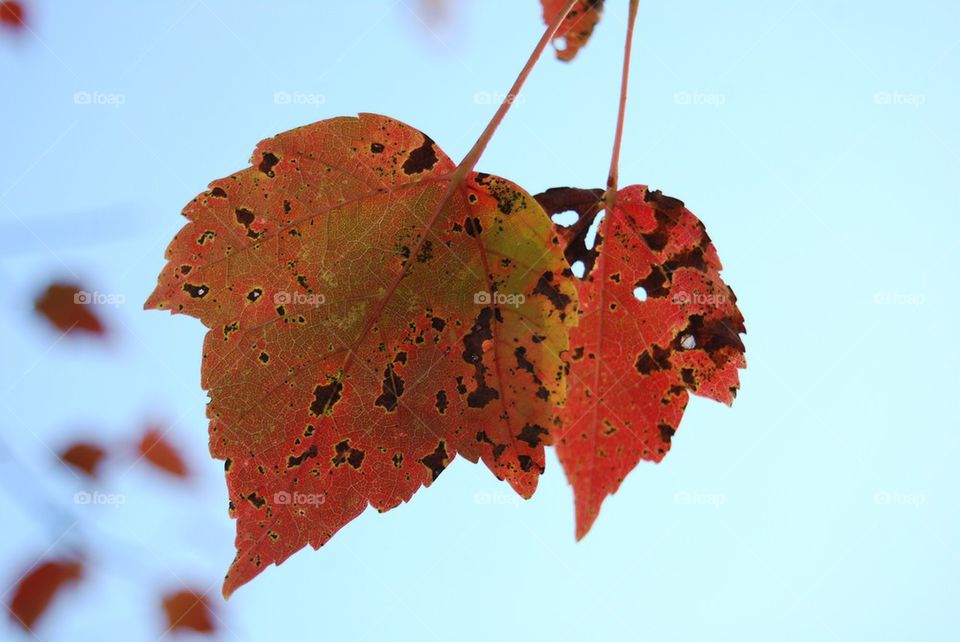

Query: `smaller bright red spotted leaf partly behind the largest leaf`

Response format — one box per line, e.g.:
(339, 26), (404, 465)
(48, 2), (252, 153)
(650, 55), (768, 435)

(537, 185), (746, 539)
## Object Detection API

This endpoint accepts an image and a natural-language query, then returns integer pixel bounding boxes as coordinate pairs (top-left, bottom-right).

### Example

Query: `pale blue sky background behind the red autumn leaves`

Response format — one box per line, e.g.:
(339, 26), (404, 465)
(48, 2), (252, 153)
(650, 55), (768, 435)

(0, 0), (960, 641)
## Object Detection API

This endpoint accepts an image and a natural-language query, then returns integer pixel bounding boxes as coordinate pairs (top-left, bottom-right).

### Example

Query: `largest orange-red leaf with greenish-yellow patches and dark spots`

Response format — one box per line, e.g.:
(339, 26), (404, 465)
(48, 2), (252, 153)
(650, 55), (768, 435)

(145, 114), (576, 595)
